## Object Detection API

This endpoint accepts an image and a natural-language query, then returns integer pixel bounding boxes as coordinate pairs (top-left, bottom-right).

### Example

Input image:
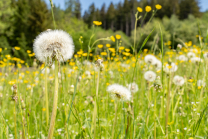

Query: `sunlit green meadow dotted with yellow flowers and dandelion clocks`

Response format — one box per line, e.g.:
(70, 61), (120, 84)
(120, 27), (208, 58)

(0, 2), (208, 139)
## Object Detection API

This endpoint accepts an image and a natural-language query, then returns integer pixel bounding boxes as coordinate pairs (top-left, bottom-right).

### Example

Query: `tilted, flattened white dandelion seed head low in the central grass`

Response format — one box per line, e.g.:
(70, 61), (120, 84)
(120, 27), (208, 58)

(107, 84), (131, 101)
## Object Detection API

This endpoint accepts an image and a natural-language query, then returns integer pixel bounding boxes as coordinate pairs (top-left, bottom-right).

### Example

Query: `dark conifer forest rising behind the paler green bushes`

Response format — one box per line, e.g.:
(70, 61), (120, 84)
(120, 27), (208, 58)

(83, 0), (202, 36)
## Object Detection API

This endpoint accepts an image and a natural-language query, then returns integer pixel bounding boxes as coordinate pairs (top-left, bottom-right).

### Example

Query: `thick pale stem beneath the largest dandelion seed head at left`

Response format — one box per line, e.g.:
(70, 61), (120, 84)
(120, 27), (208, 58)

(48, 60), (58, 139)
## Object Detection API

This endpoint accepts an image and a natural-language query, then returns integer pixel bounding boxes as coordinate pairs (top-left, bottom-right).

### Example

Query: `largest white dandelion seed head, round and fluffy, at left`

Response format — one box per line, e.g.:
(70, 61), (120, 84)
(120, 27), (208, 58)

(33, 30), (74, 62)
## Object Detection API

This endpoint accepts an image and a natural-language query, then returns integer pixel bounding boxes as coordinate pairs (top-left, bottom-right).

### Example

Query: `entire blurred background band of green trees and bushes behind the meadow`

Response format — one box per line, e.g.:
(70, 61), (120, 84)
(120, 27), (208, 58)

(0, 0), (208, 59)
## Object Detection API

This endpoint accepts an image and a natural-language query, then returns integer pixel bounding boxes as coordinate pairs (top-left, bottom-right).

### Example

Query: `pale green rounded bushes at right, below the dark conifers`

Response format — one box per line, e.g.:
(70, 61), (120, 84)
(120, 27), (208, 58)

(131, 13), (208, 49)
